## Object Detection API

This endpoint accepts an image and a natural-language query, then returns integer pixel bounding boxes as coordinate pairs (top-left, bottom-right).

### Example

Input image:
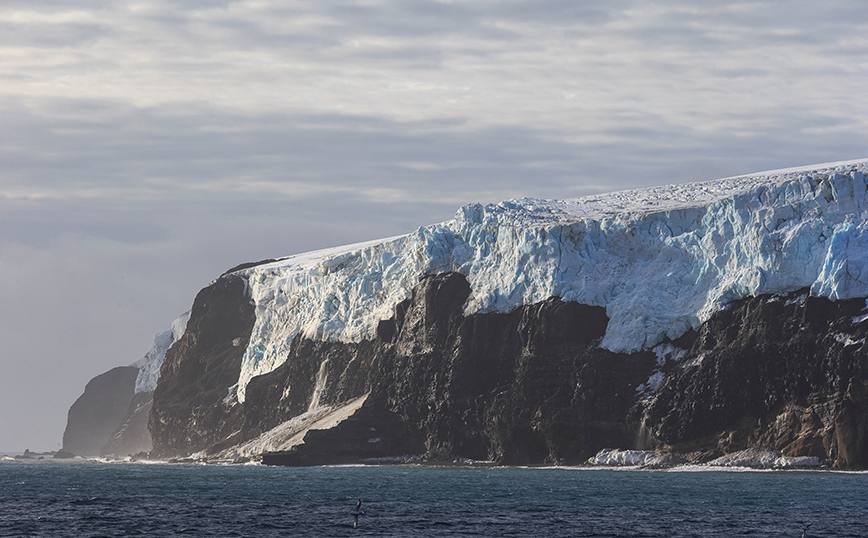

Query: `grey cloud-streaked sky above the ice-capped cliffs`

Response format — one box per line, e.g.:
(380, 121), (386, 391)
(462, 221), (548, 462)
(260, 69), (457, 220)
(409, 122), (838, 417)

(0, 0), (868, 451)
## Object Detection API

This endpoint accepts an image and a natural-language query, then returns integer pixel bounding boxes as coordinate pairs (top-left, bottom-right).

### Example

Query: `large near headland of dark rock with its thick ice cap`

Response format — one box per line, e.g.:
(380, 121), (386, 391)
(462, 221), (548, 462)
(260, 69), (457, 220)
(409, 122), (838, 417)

(64, 161), (868, 468)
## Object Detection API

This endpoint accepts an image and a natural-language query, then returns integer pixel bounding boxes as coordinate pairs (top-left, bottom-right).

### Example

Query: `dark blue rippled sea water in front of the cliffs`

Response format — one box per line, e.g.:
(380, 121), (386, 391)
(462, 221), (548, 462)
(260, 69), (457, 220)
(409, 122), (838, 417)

(0, 462), (868, 538)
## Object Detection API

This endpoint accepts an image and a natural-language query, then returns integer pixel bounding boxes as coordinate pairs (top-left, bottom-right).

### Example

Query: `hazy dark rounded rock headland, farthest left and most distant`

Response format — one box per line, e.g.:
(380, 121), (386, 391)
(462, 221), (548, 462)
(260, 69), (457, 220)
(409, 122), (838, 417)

(63, 366), (139, 456)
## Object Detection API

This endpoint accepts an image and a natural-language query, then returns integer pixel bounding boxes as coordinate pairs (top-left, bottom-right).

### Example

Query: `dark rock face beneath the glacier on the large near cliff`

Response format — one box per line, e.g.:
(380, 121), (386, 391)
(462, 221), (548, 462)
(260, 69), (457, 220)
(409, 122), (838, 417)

(150, 273), (868, 468)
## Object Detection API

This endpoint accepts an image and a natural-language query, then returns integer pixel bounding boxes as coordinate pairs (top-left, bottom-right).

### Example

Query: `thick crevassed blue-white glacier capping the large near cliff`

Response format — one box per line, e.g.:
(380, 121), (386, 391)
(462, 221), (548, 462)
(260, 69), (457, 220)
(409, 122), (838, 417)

(234, 159), (868, 402)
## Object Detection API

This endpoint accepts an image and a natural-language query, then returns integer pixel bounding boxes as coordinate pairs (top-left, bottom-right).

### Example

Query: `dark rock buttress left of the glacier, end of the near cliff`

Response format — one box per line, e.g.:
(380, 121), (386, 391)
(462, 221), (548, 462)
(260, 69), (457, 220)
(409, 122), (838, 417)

(148, 274), (254, 457)
